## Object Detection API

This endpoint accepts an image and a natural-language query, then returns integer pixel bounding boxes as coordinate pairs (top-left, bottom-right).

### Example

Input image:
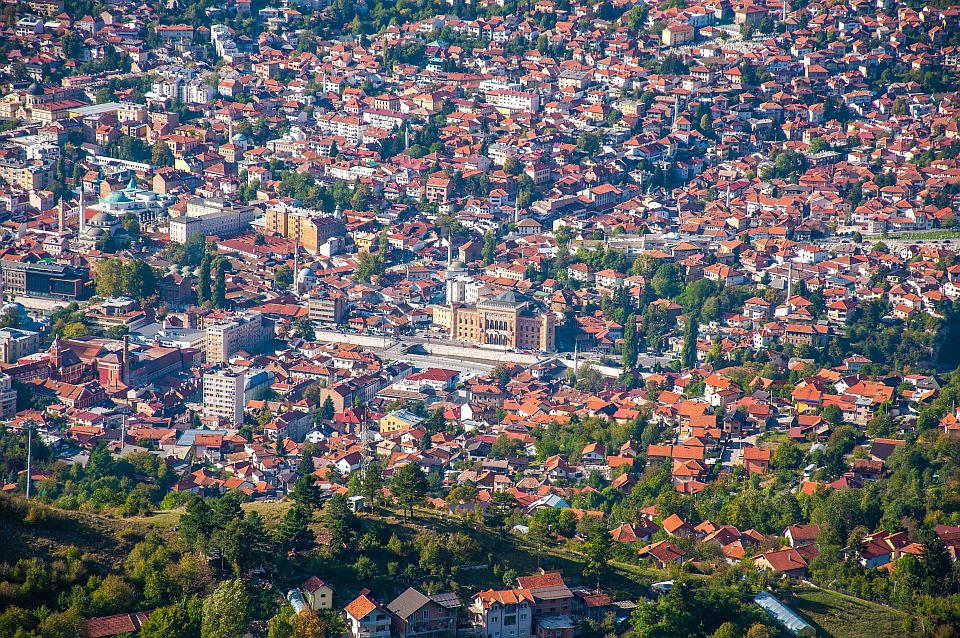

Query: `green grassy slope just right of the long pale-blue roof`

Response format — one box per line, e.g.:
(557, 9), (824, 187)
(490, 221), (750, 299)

(784, 588), (907, 638)
